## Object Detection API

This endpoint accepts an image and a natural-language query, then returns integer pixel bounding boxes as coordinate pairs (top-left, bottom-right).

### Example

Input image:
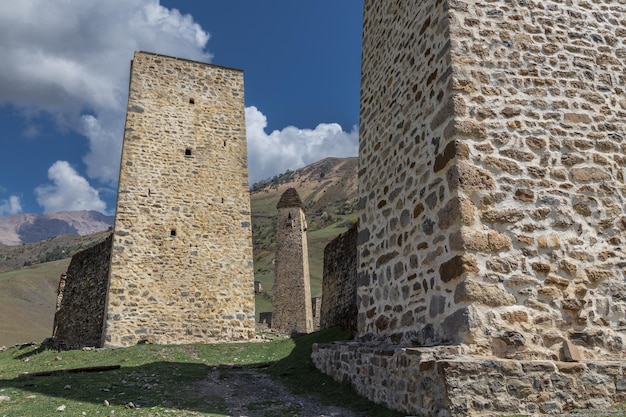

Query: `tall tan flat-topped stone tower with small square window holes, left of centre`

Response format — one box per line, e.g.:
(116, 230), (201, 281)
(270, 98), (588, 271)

(103, 52), (254, 346)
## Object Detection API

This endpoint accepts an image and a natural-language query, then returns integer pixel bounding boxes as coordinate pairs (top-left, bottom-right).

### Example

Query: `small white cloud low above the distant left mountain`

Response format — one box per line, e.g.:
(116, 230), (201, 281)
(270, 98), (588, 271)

(35, 161), (106, 213)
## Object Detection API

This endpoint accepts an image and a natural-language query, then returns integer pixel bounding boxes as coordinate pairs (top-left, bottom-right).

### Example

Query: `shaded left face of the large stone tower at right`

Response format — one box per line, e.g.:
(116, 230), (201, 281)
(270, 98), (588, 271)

(357, 0), (458, 343)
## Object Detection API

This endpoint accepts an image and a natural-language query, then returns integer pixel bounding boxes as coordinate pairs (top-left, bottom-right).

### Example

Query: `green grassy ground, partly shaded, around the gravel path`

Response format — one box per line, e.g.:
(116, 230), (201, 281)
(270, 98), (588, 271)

(0, 329), (401, 417)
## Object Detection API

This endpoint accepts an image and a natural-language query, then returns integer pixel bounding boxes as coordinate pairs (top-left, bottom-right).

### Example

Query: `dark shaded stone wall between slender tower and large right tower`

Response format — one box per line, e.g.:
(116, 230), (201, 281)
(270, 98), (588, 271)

(320, 225), (358, 332)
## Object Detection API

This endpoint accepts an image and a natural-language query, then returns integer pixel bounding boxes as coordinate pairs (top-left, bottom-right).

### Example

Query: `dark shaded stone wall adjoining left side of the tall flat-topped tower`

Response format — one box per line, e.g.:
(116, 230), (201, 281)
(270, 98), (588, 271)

(52, 235), (113, 348)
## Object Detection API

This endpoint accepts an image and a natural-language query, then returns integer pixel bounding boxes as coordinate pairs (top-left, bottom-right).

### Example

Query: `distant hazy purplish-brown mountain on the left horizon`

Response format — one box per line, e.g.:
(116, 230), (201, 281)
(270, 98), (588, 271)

(0, 211), (114, 245)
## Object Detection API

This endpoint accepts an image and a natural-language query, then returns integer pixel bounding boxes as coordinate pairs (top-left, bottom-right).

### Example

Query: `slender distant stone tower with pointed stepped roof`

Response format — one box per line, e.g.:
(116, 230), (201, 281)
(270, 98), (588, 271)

(272, 188), (313, 333)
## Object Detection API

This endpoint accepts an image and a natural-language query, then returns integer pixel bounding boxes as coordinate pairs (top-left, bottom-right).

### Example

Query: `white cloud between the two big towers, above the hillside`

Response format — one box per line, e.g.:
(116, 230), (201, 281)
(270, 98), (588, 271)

(246, 106), (359, 184)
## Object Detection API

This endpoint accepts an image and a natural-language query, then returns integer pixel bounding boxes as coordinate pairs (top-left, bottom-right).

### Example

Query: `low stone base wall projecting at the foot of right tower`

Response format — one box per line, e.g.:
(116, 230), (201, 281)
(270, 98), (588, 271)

(312, 342), (626, 417)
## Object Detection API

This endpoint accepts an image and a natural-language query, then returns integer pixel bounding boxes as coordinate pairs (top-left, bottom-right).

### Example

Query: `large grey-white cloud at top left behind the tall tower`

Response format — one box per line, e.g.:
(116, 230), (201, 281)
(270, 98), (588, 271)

(0, 0), (211, 183)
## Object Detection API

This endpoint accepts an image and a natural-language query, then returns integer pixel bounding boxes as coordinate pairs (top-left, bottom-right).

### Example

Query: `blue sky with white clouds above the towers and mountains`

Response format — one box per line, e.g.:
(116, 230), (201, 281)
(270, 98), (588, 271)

(0, 0), (363, 216)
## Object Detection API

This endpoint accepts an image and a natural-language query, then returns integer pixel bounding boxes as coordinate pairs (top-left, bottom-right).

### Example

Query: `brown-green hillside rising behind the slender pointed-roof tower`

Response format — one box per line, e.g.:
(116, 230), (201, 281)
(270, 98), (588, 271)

(250, 157), (358, 311)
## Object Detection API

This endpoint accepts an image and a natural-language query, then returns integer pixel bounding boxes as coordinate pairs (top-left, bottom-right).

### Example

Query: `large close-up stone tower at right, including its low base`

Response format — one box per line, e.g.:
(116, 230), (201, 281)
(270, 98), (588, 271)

(314, 0), (626, 415)
